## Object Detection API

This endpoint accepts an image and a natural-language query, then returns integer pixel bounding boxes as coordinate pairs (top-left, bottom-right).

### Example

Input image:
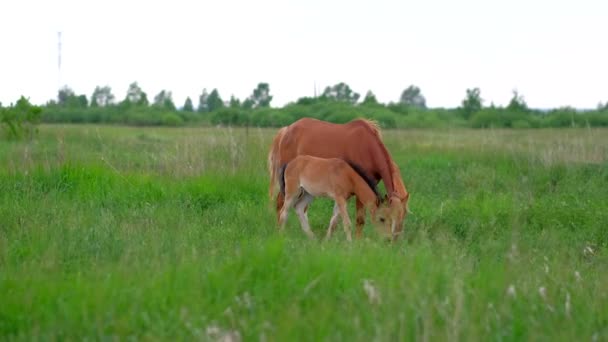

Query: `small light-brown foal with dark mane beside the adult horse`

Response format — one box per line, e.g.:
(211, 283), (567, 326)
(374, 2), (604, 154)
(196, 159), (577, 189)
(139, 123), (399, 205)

(279, 155), (390, 242)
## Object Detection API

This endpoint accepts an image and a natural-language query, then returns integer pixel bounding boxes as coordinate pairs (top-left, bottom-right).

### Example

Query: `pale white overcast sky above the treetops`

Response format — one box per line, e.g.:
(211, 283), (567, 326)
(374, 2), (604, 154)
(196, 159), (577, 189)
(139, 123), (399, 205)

(0, 0), (608, 108)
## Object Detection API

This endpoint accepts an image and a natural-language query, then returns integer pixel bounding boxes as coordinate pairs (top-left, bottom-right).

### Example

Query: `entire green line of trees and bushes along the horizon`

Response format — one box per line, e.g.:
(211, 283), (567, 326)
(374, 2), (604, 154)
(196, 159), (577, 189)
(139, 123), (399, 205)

(0, 82), (608, 135)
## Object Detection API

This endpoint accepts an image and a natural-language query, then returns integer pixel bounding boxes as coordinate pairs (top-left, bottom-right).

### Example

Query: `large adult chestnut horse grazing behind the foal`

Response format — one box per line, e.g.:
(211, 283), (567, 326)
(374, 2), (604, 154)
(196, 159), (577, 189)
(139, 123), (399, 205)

(268, 118), (409, 240)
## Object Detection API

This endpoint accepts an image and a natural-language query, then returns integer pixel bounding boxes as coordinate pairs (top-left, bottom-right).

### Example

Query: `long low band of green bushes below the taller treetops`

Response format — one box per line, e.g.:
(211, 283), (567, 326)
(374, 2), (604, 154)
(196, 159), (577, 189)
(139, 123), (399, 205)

(32, 98), (608, 128)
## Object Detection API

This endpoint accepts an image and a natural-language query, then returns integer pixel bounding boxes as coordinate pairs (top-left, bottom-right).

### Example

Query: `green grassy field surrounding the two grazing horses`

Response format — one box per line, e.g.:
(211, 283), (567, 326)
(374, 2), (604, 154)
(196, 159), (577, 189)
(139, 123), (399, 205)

(0, 126), (608, 341)
